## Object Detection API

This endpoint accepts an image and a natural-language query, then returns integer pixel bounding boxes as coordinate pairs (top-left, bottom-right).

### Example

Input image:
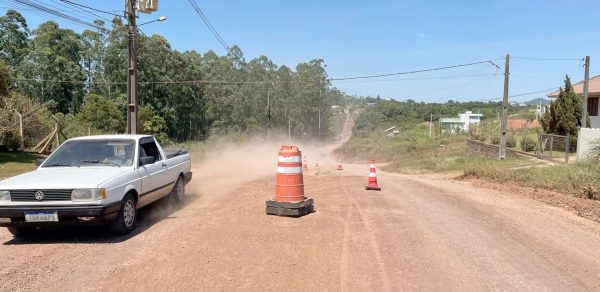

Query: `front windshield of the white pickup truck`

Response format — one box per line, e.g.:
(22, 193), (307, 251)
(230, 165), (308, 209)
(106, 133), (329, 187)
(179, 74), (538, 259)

(42, 140), (135, 167)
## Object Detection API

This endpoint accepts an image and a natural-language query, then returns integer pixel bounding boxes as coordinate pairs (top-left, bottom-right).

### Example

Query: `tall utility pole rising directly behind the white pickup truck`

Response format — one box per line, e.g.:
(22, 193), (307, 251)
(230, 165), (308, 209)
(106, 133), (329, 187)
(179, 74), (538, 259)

(127, 0), (139, 134)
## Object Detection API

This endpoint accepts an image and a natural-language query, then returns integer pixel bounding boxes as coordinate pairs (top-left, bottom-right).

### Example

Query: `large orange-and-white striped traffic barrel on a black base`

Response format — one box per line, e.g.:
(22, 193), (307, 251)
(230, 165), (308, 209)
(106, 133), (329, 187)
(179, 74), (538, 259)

(266, 145), (314, 217)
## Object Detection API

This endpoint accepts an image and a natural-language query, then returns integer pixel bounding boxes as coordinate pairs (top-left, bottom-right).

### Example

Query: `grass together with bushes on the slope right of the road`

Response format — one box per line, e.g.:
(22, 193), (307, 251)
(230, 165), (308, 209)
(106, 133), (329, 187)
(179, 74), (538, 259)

(336, 96), (600, 200)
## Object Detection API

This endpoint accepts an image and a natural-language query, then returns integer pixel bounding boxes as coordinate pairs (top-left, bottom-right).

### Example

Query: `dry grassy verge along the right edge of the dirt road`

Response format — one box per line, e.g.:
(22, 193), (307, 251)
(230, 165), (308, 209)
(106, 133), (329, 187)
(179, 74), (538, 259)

(336, 120), (600, 199)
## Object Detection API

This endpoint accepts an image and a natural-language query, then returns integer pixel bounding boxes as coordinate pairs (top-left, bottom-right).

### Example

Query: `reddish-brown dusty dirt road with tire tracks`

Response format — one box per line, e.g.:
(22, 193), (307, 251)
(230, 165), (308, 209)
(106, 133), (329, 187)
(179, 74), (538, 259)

(0, 120), (600, 291)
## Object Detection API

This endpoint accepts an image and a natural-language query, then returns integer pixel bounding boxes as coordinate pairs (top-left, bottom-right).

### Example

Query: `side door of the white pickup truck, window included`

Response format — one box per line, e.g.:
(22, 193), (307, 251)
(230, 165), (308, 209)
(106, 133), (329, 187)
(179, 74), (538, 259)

(139, 137), (173, 206)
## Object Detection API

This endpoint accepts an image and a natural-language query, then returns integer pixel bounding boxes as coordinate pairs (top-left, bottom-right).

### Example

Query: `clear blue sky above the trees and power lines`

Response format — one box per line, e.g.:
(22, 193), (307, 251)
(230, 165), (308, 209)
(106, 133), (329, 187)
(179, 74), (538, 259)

(0, 0), (600, 102)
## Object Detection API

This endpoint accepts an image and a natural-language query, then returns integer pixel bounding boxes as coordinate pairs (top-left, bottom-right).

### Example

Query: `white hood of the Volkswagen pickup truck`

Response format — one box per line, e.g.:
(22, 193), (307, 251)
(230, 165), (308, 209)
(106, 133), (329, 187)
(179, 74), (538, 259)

(0, 167), (131, 190)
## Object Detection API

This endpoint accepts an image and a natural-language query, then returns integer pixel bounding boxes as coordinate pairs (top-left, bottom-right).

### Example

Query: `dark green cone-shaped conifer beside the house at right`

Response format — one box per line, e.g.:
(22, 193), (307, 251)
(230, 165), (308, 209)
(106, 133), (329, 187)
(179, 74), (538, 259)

(541, 76), (583, 136)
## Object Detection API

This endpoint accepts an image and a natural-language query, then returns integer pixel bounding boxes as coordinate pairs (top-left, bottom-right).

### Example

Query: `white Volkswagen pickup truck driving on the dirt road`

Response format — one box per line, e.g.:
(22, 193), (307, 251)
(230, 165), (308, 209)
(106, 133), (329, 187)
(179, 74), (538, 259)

(0, 135), (192, 236)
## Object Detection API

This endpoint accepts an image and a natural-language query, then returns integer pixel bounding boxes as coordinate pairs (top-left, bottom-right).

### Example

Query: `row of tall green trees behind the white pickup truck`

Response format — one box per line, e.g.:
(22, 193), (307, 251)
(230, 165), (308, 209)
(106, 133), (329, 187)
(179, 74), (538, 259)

(0, 9), (349, 149)
